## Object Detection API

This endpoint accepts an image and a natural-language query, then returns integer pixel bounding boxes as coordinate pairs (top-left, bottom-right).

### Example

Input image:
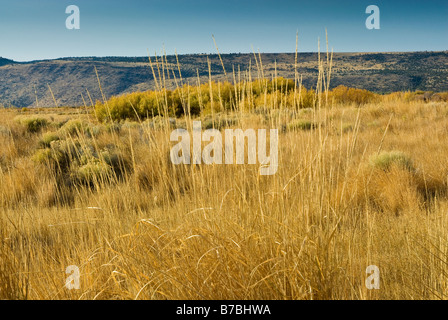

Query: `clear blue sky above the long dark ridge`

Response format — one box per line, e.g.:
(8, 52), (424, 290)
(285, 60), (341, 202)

(0, 0), (448, 61)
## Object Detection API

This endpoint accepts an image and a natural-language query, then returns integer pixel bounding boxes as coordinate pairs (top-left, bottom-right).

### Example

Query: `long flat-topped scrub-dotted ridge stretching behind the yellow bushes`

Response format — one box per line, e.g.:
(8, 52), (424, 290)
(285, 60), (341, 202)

(0, 51), (448, 107)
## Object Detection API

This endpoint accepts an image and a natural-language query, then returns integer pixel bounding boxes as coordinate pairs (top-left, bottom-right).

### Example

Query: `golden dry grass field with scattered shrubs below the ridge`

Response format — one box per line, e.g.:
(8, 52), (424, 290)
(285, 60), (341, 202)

(0, 51), (448, 300)
